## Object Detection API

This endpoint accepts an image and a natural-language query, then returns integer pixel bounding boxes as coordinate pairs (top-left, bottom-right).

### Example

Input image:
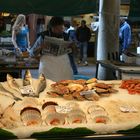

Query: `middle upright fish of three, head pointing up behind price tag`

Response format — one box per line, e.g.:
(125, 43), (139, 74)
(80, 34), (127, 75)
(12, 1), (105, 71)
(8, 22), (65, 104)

(23, 70), (32, 86)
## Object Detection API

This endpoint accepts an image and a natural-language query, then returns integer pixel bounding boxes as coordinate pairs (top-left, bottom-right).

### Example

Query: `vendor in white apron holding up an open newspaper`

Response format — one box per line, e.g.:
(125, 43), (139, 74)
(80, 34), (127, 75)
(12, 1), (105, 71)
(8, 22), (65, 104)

(30, 17), (73, 81)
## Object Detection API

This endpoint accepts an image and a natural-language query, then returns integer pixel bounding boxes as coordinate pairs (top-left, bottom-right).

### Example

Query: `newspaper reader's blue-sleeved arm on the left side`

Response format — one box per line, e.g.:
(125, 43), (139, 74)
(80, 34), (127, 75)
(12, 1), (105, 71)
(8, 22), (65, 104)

(29, 36), (43, 56)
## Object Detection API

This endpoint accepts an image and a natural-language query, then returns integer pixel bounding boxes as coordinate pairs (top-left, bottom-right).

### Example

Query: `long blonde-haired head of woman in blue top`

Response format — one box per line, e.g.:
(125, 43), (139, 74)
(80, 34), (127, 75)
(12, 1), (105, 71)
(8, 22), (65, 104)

(13, 14), (26, 29)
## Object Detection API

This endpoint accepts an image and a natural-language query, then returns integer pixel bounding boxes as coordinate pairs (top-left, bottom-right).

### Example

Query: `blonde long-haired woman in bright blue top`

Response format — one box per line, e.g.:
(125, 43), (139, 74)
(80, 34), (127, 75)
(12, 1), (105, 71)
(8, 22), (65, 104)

(12, 14), (30, 53)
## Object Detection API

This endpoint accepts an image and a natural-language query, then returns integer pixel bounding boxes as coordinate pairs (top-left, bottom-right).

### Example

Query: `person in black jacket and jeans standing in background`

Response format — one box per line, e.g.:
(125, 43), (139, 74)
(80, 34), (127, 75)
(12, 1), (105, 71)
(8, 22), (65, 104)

(76, 20), (91, 66)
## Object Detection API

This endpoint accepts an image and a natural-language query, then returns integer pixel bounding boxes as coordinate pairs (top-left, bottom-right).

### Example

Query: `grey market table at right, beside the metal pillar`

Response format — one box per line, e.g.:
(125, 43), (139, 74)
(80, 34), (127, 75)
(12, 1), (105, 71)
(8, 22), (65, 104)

(96, 60), (140, 80)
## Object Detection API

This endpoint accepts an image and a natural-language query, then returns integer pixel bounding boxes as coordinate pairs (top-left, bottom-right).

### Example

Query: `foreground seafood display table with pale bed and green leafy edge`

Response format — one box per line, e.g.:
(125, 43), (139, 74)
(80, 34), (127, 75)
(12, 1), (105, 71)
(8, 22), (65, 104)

(0, 78), (140, 139)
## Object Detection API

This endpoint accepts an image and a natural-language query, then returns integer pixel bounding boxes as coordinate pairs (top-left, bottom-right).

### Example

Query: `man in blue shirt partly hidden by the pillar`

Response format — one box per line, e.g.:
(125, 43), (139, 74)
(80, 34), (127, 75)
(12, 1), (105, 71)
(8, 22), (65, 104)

(119, 18), (131, 54)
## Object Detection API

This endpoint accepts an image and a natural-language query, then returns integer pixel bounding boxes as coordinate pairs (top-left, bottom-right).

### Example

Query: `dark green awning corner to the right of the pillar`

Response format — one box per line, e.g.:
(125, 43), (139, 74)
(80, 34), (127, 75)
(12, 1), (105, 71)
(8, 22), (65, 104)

(128, 0), (140, 21)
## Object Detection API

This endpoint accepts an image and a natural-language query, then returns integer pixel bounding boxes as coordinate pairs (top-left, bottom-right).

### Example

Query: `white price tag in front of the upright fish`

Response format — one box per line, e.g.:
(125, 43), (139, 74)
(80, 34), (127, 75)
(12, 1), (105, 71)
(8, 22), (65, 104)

(20, 85), (35, 96)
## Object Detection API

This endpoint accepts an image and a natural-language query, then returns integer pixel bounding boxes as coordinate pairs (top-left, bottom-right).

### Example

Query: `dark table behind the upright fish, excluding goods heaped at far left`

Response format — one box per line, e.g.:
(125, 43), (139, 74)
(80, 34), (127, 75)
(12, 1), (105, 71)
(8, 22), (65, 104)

(0, 57), (39, 81)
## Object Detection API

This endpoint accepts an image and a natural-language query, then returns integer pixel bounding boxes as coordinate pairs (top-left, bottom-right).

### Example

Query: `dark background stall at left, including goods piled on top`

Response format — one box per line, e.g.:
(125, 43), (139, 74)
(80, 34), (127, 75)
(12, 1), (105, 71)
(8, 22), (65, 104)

(0, 49), (39, 82)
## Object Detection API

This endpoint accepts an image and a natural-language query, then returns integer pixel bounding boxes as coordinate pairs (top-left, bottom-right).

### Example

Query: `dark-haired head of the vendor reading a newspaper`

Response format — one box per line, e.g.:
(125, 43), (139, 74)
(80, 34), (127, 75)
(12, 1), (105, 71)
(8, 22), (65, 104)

(49, 17), (64, 34)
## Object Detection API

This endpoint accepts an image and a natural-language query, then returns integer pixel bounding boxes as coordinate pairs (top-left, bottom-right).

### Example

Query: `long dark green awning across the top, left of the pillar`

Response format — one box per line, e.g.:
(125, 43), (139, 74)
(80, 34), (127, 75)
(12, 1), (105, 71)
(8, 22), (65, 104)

(0, 0), (98, 16)
